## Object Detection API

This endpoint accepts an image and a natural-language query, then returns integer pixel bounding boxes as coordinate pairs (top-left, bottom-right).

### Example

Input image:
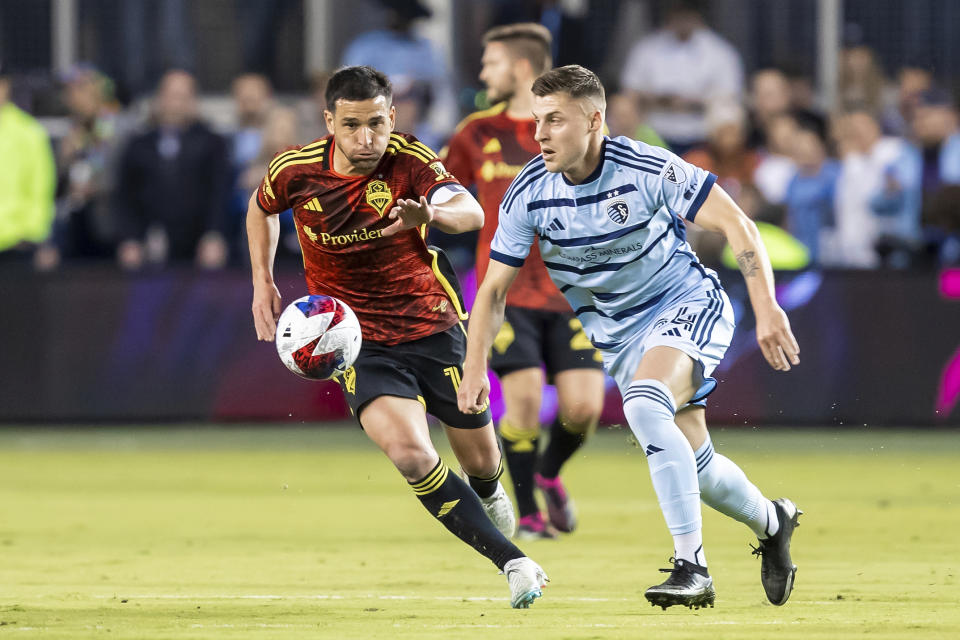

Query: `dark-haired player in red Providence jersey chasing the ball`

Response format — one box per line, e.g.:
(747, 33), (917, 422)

(247, 67), (546, 608)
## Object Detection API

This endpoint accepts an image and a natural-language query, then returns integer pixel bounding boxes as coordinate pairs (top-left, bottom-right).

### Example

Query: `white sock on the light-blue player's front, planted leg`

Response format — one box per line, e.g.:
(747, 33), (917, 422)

(623, 380), (706, 566)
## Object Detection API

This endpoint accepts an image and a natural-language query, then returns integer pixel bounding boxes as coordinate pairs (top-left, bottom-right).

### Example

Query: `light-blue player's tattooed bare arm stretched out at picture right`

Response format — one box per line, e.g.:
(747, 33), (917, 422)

(695, 185), (800, 371)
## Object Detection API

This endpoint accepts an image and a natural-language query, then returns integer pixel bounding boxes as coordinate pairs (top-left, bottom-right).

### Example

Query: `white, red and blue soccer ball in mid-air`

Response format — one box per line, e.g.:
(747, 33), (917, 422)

(277, 296), (362, 380)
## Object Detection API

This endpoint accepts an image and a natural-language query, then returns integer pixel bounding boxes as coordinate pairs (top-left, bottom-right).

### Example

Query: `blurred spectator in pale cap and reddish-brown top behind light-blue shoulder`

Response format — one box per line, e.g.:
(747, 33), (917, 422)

(683, 99), (758, 202)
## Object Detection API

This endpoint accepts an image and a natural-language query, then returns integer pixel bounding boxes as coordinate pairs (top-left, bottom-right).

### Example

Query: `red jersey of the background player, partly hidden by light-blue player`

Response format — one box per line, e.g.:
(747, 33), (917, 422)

(443, 103), (570, 311)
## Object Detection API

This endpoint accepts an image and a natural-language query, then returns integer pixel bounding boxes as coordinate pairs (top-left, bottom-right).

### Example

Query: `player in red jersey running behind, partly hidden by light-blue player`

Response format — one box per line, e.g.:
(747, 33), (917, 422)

(443, 23), (604, 538)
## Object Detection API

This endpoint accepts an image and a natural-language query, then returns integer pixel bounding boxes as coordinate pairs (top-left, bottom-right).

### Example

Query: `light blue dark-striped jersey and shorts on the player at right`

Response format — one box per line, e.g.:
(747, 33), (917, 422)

(490, 137), (733, 395)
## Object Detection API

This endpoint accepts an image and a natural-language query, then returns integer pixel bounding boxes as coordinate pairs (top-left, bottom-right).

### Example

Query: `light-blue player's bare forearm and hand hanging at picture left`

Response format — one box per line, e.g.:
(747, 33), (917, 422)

(457, 260), (519, 413)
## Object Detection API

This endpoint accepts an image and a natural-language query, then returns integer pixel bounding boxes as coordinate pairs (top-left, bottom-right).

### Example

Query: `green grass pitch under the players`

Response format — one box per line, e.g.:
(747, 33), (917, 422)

(0, 426), (960, 640)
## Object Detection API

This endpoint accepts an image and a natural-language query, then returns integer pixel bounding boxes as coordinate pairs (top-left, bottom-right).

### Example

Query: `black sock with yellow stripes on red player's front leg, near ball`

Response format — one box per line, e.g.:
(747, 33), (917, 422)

(410, 460), (524, 571)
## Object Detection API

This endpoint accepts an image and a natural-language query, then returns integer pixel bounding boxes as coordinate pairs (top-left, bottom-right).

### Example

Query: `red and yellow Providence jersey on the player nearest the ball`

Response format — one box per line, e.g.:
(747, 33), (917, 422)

(257, 133), (466, 345)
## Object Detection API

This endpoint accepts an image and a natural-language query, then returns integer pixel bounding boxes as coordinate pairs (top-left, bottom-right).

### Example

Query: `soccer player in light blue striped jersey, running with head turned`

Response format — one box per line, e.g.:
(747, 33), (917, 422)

(458, 65), (801, 609)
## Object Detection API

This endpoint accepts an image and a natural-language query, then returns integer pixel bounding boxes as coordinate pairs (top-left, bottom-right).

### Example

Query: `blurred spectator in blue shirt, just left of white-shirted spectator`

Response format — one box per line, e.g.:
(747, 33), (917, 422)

(783, 119), (840, 264)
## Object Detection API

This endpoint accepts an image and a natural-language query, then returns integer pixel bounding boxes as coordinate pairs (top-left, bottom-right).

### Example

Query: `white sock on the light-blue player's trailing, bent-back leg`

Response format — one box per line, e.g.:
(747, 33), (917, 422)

(694, 437), (780, 539)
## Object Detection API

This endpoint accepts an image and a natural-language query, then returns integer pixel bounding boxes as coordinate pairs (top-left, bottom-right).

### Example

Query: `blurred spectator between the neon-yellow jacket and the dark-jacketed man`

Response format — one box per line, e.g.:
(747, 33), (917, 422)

(41, 64), (126, 268)
